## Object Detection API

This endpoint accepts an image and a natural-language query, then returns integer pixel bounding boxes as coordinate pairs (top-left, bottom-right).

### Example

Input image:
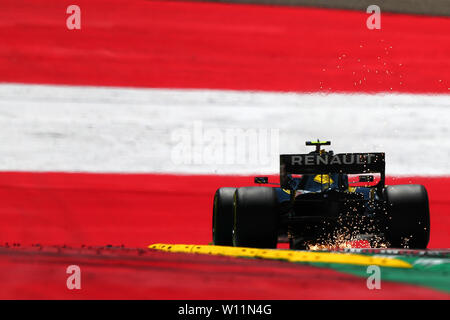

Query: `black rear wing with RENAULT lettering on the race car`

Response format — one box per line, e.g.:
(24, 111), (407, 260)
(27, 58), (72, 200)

(280, 152), (385, 189)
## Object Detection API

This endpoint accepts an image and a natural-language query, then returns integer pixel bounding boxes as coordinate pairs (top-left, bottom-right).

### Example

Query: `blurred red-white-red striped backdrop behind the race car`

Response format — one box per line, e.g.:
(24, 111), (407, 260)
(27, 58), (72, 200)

(0, 0), (450, 296)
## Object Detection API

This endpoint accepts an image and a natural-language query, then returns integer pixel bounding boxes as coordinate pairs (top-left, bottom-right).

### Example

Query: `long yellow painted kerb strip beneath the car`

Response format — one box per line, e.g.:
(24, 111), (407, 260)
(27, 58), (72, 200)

(148, 243), (412, 268)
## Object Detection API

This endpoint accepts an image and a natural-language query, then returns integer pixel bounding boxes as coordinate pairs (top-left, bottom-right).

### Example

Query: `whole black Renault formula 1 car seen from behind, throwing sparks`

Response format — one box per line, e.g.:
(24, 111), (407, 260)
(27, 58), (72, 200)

(212, 141), (430, 249)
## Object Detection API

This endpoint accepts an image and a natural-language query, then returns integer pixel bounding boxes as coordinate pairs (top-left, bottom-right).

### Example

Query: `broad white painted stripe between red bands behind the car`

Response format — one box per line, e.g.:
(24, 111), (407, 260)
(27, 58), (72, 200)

(0, 84), (450, 175)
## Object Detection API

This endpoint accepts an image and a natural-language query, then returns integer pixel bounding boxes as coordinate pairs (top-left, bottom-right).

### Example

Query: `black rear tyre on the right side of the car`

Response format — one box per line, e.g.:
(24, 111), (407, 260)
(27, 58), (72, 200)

(384, 185), (430, 249)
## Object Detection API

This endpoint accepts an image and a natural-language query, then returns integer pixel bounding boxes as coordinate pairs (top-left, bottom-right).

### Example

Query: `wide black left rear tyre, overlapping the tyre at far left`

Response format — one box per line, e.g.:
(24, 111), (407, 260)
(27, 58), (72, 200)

(233, 187), (279, 248)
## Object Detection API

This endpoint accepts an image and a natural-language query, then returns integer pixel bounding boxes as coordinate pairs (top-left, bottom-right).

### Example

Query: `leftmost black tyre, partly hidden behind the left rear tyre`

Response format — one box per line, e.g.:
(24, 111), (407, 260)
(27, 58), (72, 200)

(212, 188), (236, 246)
